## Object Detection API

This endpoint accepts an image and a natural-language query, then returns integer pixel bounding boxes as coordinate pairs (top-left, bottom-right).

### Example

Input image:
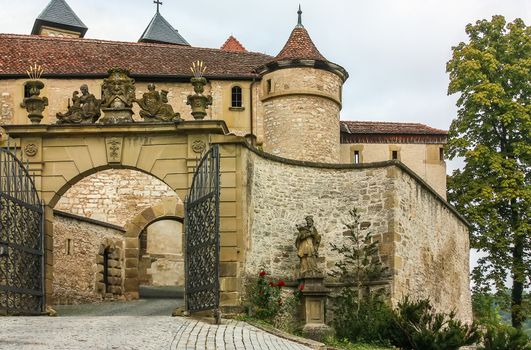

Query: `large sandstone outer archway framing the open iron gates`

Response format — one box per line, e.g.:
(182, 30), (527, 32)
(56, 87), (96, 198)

(0, 120), (243, 307)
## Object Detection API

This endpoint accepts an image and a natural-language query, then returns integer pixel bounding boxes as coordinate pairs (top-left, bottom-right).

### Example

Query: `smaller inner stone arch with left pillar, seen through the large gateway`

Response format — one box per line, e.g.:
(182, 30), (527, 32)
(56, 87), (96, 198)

(124, 197), (184, 299)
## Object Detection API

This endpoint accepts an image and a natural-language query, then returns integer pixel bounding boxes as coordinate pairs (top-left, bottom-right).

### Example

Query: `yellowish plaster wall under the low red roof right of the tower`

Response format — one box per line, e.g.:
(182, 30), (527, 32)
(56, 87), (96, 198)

(341, 143), (446, 198)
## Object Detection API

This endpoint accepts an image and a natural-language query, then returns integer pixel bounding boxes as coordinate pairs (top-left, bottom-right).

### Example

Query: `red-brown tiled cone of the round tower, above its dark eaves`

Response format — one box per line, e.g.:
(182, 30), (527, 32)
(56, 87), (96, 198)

(275, 26), (326, 61)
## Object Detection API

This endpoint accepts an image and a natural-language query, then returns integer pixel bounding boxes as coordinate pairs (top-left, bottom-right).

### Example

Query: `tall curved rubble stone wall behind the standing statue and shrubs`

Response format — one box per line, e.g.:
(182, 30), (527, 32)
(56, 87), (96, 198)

(245, 152), (471, 321)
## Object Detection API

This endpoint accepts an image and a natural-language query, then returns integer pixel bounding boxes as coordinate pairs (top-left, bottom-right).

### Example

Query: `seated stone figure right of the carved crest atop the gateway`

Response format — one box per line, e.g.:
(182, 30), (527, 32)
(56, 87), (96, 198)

(135, 83), (182, 122)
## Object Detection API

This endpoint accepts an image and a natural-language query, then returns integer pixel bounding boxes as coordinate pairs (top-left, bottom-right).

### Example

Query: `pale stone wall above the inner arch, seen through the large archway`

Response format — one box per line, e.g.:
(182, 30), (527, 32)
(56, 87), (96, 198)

(55, 169), (175, 226)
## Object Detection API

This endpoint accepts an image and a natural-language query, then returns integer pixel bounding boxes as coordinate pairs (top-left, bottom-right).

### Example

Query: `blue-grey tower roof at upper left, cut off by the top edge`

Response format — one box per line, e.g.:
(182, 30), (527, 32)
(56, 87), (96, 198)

(31, 0), (88, 37)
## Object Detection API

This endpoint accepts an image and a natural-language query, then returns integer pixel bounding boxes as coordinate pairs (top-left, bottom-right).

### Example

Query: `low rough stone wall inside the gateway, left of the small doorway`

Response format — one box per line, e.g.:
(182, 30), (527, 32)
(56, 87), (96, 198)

(53, 212), (123, 304)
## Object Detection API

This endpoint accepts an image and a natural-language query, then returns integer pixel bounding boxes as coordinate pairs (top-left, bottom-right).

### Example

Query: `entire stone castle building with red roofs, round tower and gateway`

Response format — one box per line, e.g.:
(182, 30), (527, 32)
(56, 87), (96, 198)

(0, 0), (471, 320)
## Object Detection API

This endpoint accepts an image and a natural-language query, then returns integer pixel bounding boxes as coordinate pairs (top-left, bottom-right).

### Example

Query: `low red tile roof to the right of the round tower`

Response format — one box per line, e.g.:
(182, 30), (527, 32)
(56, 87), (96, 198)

(341, 121), (448, 143)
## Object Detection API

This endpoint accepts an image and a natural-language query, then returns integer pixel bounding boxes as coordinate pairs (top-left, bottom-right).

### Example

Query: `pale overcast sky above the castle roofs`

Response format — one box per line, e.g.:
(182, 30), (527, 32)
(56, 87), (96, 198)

(0, 0), (531, 170)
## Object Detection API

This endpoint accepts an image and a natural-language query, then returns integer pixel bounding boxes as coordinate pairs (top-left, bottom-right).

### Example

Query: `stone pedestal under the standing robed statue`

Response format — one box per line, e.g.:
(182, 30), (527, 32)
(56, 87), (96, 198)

(302, 276), (334, 341)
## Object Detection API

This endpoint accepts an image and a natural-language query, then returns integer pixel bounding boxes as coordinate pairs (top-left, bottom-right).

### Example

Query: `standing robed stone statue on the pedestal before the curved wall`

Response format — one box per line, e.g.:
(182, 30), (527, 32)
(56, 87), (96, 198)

(295, 215), (321, 277)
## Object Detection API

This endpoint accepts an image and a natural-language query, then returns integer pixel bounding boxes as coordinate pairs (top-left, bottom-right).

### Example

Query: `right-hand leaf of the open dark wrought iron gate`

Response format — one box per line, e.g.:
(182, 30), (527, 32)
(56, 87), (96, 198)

(184, 145), (220, 317)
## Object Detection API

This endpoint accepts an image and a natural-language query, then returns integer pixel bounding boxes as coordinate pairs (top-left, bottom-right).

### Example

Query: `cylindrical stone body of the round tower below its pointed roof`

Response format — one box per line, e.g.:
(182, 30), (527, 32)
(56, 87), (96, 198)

(262, 68), (343, 163)
